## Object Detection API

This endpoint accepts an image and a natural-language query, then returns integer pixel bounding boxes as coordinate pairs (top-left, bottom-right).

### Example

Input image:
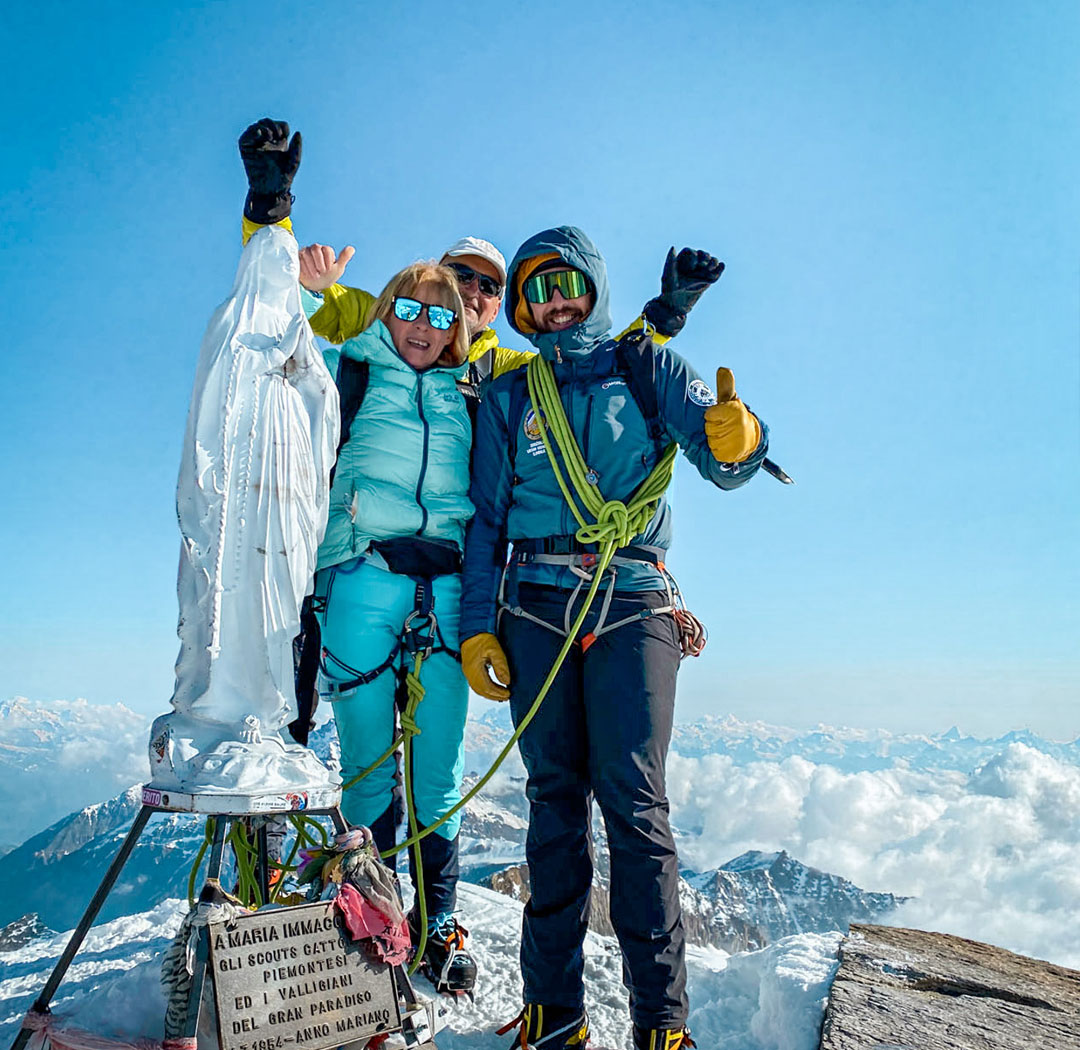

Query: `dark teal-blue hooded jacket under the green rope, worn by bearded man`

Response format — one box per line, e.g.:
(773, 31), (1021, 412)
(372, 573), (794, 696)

(461, 227), (769, 638)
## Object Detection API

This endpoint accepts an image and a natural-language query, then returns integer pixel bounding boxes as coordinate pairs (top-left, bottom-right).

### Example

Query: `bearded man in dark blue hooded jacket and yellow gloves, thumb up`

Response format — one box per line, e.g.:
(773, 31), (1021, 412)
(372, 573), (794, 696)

(461, 227), (768, 1050)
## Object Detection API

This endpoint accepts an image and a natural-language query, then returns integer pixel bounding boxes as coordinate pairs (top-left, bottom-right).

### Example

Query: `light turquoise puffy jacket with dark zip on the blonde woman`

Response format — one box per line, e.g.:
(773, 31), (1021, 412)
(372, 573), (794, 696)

(319, 321), (473, 568)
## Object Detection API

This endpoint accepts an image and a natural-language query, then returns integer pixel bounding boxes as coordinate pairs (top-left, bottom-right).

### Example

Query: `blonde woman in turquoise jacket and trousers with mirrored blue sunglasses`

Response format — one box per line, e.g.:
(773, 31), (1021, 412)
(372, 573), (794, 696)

(315, 263), (475, 992)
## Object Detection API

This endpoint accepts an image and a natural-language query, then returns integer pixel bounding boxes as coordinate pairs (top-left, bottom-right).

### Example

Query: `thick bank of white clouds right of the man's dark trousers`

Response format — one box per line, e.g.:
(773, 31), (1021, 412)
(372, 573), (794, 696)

(669, 743), (1080, 967)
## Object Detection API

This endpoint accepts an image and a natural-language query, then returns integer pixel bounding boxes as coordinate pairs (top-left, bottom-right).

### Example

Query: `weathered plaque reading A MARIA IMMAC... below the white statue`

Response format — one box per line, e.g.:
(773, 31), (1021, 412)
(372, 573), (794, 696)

(210, 901), (401, 1050)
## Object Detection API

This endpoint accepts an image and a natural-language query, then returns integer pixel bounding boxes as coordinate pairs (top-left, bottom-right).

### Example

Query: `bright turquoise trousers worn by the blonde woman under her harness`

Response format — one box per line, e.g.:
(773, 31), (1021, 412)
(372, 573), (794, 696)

(318, 554), (469, 839)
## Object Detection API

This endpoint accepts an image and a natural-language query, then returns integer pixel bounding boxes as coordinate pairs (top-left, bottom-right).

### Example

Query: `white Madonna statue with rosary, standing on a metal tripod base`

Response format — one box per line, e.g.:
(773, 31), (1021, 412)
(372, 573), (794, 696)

(150, 226), (339, 795)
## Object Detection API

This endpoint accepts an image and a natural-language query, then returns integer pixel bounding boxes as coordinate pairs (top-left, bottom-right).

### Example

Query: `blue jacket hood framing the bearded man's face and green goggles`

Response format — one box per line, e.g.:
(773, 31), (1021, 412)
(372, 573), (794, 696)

(507, 226), (611, 361)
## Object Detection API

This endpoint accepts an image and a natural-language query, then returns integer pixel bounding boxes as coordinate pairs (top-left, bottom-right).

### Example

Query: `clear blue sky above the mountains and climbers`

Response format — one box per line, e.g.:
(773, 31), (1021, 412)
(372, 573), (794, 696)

(0, 0), (1080, 738)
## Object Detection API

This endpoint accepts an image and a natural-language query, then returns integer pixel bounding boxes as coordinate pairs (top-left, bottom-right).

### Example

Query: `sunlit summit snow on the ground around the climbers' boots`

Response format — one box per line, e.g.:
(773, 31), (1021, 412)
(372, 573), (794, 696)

(0, 884), (840, 1050)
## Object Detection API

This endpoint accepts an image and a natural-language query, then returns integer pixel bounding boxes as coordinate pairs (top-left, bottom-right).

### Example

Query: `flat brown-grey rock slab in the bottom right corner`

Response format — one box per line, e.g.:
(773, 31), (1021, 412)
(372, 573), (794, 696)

(821, 925), (1080, 1050)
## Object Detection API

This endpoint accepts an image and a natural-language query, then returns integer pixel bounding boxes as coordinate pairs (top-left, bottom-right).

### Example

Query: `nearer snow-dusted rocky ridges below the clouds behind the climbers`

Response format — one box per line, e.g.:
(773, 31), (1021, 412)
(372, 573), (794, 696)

(0, 764), (903, 952)
